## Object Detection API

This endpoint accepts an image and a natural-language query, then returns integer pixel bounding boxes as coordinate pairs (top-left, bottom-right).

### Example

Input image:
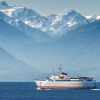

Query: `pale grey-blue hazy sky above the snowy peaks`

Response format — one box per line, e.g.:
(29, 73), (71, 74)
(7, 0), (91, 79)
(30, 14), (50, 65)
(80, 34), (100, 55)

(0, 0), (100, 15)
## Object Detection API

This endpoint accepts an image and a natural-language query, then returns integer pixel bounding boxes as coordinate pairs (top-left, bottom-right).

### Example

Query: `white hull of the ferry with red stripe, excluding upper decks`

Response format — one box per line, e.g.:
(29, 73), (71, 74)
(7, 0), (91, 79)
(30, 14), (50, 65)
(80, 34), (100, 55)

(35, 80), (97, 89)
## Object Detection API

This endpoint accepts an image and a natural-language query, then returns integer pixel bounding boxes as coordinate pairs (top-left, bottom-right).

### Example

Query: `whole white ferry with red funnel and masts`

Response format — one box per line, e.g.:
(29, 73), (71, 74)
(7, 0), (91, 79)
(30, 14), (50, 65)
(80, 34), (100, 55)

(35, 66), (97, 89)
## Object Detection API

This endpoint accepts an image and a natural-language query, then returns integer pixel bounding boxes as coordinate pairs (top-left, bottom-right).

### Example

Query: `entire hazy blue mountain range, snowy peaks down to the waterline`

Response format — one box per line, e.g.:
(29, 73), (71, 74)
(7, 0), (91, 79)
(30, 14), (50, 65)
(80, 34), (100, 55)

(0, 1), (100, 81)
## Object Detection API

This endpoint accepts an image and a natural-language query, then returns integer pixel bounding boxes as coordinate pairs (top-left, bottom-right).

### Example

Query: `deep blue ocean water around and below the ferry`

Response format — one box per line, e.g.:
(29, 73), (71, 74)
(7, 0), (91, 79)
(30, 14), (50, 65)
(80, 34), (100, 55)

(0, 82), (100, 100)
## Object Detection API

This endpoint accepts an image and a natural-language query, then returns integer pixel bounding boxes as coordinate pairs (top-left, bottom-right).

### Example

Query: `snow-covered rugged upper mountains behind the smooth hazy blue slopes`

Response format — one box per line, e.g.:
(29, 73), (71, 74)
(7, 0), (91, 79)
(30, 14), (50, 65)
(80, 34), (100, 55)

(0, 1), (100, 37)
